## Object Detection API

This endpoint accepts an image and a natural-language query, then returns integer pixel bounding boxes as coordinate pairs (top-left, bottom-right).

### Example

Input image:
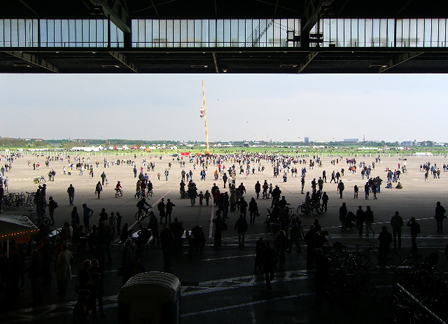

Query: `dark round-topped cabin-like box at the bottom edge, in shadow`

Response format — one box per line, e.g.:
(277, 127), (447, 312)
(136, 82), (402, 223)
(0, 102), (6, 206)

(118, 271), (181, 324)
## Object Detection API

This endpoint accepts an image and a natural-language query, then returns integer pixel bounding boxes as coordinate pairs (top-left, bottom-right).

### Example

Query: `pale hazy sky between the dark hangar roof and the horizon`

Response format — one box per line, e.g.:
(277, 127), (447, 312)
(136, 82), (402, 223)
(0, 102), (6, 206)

(0, 74), (448, 144)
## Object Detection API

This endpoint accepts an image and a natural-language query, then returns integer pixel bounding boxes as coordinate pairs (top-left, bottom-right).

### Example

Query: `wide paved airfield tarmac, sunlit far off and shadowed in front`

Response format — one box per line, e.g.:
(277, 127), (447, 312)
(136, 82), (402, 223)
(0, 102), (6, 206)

(0, 155), (448, 323)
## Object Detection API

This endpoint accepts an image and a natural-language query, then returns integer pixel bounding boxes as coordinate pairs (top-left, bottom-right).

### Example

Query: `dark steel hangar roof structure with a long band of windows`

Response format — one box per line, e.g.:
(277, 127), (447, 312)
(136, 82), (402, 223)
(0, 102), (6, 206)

(0, 0), (448, 73)
